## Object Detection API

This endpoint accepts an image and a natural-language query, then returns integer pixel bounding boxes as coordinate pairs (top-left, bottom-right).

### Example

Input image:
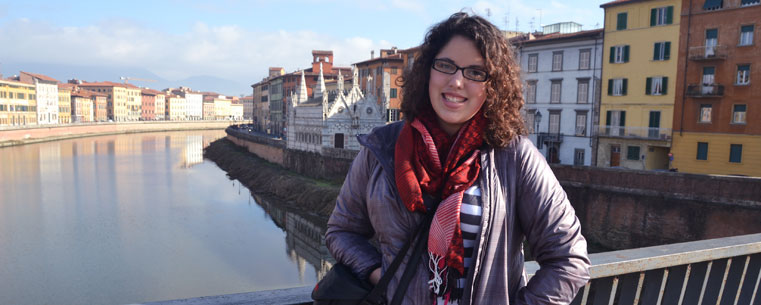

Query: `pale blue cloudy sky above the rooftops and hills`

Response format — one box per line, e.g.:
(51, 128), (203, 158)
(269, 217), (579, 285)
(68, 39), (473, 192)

(0, 0), (604, 94)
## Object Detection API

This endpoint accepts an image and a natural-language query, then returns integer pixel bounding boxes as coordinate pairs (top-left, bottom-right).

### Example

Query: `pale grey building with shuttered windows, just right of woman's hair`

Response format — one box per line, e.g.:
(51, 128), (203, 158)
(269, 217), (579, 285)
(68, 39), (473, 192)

(511, 24), (603, 166)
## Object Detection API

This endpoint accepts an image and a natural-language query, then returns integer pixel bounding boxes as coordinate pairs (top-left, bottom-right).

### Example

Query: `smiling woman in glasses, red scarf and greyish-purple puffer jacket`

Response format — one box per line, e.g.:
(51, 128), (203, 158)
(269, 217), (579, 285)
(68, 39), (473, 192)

(325, 13), (589, 304)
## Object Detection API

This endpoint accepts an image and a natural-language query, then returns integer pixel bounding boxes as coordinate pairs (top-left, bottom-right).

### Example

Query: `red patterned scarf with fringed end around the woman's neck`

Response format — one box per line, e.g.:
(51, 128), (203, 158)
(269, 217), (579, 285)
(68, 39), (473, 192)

(394, 108), (486, 296)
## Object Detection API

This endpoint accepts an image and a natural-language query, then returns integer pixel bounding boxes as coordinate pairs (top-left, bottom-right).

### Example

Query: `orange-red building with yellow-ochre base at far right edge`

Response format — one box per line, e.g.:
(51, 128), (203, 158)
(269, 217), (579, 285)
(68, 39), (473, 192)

(672, 0), (761, 176)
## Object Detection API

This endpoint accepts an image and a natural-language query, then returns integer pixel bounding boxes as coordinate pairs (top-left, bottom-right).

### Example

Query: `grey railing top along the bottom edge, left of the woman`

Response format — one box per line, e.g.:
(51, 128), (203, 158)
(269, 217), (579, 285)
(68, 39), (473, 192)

(135, 286), (313, 305)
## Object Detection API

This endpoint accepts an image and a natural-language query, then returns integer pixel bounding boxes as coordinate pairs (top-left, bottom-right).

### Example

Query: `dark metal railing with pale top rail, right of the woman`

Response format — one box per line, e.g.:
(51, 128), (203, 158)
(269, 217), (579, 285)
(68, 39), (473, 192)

(526, 234), (761, 305)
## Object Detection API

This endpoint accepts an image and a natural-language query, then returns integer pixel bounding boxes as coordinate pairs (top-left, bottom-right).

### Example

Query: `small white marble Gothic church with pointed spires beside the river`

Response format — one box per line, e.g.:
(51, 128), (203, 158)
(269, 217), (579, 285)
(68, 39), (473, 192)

(287, 64), (389, 154)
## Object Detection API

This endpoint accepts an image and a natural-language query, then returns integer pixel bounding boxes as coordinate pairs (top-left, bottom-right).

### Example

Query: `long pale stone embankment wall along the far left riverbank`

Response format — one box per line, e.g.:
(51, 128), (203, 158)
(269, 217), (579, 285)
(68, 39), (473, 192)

(0, 121), (235, 147)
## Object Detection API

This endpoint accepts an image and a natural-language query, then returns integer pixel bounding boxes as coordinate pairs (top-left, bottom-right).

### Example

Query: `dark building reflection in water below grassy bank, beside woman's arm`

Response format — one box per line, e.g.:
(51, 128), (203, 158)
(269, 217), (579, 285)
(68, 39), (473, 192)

(254, 195), (335, 282)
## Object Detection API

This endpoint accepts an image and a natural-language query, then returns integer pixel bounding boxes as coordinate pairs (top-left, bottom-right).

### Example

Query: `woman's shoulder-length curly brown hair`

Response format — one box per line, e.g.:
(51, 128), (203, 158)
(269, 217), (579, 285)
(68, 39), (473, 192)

(400, 12), (526, 147)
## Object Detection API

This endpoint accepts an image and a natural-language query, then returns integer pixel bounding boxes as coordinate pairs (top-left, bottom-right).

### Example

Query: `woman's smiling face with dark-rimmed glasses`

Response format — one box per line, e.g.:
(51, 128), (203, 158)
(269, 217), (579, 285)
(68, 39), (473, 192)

(428, 36), (486, 136)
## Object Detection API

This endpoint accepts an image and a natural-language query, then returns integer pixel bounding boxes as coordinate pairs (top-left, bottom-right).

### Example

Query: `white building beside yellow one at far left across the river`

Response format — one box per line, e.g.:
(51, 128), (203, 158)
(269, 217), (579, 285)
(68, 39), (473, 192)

(18, 71), (58, 125)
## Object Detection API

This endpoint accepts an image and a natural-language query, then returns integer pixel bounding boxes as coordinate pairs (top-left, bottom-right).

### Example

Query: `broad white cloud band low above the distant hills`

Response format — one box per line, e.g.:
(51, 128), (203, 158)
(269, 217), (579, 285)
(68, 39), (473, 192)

(0, 19), (391, 83)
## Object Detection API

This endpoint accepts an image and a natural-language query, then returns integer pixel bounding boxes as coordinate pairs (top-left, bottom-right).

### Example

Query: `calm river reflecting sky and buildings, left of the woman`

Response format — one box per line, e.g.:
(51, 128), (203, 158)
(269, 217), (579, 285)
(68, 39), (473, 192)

(0, 130), (330, 304)
